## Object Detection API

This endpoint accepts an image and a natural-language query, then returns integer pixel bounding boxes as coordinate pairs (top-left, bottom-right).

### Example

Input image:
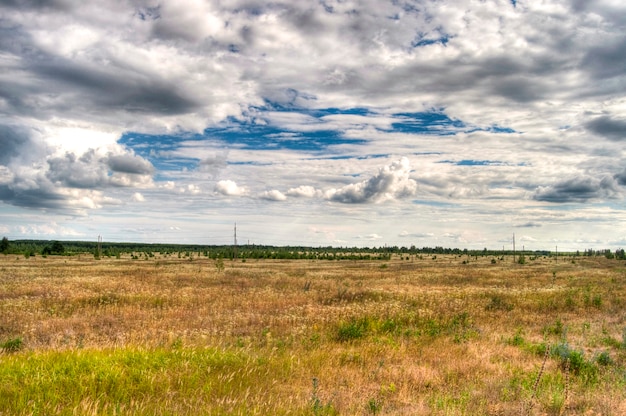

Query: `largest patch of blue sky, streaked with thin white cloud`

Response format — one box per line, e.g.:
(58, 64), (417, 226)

(118, 101), (513, 171)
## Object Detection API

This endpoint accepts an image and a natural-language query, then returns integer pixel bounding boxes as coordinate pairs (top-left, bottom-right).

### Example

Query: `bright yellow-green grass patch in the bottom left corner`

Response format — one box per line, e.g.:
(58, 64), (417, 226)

(0, 348), (288, 415)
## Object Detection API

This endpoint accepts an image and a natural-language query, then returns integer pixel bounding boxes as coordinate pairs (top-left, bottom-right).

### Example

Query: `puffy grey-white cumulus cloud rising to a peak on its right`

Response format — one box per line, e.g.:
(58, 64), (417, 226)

(326, 157), (417, 204)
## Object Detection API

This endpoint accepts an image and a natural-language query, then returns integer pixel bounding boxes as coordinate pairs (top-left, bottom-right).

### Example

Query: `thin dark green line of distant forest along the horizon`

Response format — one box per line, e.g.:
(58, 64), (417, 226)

(0, 237), (626, 260)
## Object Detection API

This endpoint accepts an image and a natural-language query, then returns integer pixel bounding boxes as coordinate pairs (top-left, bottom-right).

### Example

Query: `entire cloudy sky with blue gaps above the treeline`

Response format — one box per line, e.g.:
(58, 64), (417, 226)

(0, 0), (626, 251)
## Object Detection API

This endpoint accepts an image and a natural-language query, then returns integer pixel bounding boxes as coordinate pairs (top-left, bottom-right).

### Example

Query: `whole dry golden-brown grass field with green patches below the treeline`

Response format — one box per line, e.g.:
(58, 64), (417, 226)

(0, 253), (626, 415)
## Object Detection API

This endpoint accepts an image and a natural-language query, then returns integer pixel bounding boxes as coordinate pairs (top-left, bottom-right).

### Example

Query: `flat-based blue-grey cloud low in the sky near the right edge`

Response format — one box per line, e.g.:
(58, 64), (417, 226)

(533, 176), (622, 203)
